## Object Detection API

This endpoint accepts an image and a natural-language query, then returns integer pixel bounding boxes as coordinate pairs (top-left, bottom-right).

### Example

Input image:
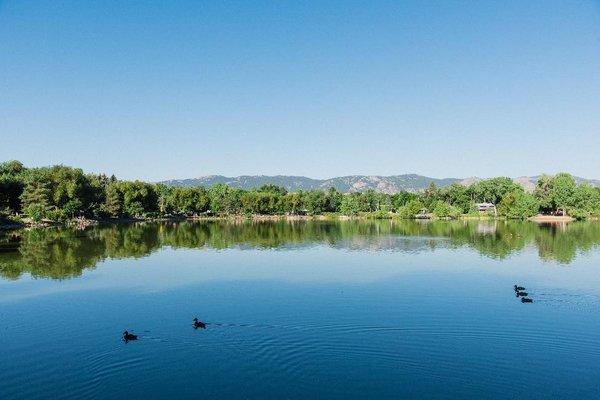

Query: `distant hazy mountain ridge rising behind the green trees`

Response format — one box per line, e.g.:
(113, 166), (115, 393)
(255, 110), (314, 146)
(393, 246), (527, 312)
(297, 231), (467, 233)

(160, 174), (600, 193)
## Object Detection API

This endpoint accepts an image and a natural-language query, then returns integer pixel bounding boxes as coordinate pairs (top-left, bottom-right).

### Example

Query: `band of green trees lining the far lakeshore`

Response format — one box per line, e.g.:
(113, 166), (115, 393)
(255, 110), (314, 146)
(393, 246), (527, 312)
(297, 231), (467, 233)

(0, 161), (600, 227)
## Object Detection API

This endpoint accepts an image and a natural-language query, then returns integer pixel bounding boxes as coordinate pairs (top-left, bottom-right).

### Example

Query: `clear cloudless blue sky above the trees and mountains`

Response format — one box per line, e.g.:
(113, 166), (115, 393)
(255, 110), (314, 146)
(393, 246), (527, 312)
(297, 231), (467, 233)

(0, 0), (600, 181)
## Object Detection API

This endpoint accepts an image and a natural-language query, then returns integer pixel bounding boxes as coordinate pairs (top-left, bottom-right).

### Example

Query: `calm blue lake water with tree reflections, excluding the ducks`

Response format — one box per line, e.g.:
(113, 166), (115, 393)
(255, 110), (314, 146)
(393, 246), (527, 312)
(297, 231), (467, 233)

(0, 221), (600, 400)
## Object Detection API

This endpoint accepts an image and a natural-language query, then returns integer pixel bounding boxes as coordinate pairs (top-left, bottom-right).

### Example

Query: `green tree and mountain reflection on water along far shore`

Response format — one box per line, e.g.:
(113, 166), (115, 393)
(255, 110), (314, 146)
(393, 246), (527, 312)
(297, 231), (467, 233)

(0, 220), (600, 279)
